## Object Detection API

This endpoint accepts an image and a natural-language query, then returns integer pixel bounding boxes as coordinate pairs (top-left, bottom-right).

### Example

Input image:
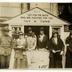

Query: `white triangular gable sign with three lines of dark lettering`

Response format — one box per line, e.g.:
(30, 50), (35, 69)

(5, 7), (69, 26)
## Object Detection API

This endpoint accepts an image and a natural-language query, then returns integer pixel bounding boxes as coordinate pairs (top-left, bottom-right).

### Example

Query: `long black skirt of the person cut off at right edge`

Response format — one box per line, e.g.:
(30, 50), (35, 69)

(65, 49), (72, 68)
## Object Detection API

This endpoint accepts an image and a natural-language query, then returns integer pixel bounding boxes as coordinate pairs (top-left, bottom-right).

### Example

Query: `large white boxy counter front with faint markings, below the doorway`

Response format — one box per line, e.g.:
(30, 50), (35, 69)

(27, 49), (49, 69)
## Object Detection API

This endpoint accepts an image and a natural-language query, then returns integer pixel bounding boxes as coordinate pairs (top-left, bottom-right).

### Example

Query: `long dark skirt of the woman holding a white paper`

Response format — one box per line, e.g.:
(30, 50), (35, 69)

(49, 52), (62, 68)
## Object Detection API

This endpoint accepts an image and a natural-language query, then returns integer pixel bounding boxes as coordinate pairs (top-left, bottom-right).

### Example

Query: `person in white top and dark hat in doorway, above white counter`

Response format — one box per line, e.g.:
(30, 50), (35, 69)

(26, 27), (36, 50)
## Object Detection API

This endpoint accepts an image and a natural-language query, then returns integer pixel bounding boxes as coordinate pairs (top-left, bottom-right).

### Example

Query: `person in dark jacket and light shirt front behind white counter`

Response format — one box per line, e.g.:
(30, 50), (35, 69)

(37, 27), (48, 49)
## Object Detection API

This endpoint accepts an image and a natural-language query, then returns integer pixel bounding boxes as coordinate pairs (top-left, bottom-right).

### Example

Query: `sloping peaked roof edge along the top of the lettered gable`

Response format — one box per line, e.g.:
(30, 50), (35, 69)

(5, 7), (71, 24)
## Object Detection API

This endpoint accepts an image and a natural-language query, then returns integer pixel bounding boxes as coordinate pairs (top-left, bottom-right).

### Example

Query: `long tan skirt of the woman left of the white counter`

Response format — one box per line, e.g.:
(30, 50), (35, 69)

(14, 50), (27, 69)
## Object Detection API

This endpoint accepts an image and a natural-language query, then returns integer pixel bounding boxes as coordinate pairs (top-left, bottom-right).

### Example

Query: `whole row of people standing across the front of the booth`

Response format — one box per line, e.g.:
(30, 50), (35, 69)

(0, 27), (72, 69)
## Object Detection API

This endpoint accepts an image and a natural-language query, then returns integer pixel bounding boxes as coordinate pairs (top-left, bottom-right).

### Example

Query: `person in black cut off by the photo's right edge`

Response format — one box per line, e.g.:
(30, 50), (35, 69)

(66, 32), (72, 68)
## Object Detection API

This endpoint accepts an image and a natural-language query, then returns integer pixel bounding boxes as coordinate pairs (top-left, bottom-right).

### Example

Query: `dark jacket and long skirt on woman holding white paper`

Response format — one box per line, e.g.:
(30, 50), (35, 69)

(48, 38), (64, 68)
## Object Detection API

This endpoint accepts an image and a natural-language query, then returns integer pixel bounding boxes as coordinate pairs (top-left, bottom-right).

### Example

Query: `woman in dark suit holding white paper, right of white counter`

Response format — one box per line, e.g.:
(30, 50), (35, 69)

(48, 32), (64, 68)
